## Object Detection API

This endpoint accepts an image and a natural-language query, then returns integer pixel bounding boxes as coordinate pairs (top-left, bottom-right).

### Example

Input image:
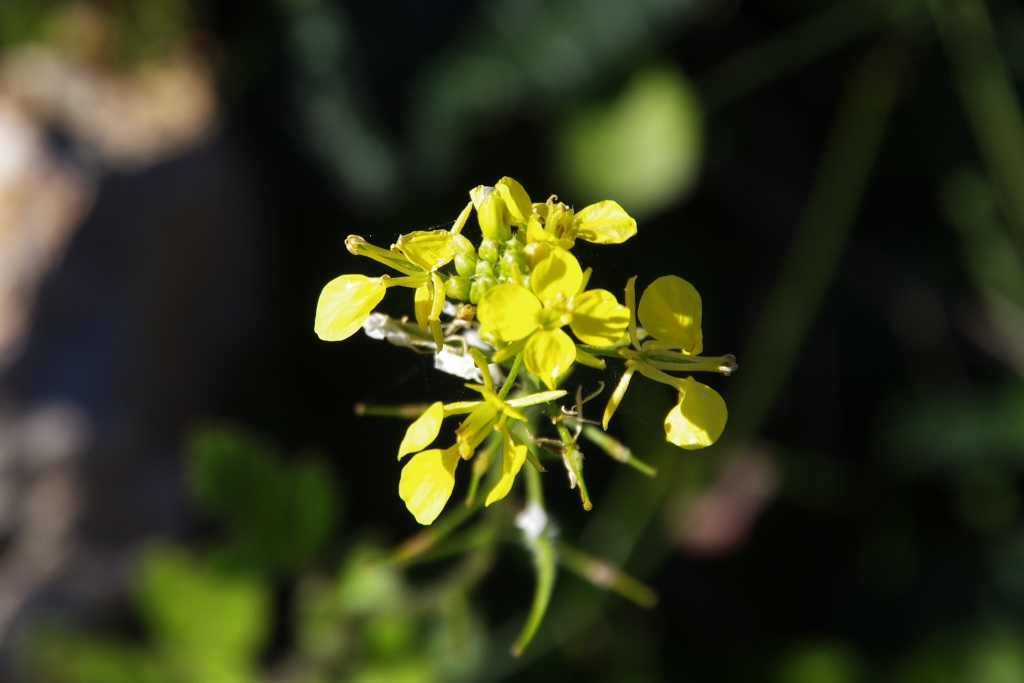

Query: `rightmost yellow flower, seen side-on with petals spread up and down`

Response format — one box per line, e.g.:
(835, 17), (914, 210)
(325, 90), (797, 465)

(602, 275), (736, 450)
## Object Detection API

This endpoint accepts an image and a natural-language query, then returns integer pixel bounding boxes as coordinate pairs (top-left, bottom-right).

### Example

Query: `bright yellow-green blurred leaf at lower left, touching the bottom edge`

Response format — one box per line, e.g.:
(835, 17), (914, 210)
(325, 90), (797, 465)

(135, 547), (270, 683)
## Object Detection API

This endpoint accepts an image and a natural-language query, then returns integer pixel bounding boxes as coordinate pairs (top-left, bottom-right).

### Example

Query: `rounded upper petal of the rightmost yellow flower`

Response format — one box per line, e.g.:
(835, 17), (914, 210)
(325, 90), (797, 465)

(637, 275), (701, 353)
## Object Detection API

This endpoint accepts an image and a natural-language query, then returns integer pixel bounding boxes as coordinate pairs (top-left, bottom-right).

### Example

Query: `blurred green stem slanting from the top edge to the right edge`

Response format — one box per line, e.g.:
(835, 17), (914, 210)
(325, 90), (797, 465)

(929, 0), (1024, 254)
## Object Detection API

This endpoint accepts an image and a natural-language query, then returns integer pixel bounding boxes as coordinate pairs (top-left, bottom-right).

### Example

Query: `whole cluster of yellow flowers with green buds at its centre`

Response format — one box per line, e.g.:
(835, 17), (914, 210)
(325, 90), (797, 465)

(314, 177), (736, 524)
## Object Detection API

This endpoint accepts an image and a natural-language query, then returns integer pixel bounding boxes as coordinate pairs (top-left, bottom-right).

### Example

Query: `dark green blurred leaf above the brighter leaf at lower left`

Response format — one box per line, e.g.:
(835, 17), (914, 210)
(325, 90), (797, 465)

(188, 428), (339, 575)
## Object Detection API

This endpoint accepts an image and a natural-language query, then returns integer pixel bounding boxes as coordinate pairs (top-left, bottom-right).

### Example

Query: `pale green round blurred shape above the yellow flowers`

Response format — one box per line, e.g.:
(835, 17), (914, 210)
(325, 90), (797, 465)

(555, 67), (703, 216)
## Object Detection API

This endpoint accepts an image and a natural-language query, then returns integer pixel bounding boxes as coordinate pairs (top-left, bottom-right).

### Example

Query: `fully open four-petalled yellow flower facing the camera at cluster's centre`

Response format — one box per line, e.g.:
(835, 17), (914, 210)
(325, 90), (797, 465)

(476, 247), (629, 389)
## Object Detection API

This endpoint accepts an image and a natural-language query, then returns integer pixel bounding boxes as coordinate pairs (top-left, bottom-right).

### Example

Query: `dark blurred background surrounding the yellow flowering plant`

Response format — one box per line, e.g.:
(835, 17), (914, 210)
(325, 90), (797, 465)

(0, 0), (1024, 683)
